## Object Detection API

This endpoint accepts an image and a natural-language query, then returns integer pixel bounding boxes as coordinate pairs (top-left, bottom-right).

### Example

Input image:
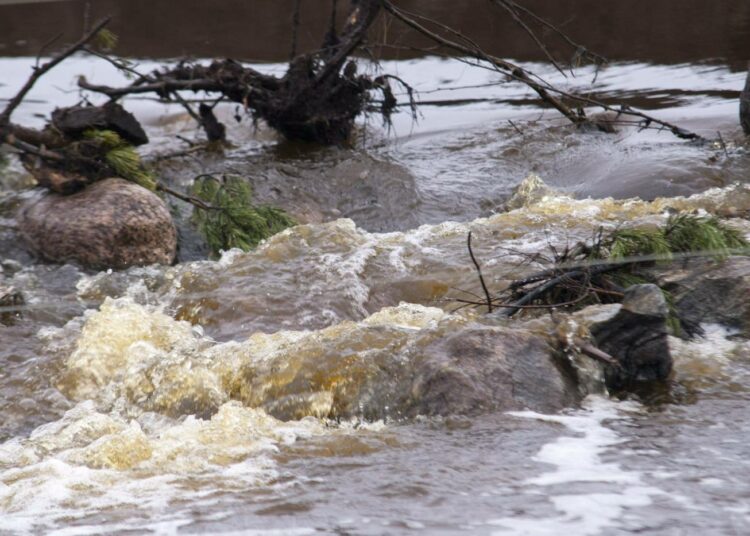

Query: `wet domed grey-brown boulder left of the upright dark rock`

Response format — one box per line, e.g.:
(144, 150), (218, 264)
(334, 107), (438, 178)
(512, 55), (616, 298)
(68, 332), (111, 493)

(407, 326), (580, 416)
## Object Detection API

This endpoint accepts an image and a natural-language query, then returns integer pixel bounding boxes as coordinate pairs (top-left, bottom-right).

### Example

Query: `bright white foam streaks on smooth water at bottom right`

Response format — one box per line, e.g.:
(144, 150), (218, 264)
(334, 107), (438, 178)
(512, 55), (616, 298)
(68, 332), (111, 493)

(488, 396), (664, 536)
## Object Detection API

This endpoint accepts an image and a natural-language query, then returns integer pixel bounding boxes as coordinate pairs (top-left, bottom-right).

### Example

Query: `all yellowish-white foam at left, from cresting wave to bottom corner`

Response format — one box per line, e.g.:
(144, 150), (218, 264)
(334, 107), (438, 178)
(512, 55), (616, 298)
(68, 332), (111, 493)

(0, 297), (447, 535)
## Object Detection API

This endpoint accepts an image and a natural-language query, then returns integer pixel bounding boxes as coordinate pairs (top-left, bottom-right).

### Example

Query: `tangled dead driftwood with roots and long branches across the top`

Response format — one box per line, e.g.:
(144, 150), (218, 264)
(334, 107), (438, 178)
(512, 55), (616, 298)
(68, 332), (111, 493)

(0, 0), (724, 205)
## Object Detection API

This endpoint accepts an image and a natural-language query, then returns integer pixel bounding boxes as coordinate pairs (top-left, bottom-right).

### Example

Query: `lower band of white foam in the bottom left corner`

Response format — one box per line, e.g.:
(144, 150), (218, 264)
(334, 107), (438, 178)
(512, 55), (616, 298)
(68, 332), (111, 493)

(0, 401), (326, 536)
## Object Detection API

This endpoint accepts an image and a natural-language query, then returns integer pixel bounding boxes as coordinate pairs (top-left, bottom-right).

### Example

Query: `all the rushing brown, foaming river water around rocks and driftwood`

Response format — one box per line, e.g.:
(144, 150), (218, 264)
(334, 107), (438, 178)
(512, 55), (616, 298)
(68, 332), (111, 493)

(0, 2), (750, 535)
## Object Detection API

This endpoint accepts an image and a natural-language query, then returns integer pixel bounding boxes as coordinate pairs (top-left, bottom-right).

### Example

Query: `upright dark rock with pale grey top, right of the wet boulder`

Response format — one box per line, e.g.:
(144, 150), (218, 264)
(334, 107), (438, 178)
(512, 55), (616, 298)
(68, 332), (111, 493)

(589, 284), (672, 389)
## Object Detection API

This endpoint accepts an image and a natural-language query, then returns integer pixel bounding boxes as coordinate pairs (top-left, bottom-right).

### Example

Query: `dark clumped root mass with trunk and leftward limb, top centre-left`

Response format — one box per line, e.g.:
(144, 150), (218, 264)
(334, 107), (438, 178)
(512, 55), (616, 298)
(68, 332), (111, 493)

(72, 0), (390, 144)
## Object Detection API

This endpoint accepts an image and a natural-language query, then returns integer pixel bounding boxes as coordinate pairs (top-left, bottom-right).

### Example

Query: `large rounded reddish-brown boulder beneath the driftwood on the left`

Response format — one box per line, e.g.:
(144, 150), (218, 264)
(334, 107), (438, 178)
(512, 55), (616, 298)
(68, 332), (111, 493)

(18, 179), (177, 269)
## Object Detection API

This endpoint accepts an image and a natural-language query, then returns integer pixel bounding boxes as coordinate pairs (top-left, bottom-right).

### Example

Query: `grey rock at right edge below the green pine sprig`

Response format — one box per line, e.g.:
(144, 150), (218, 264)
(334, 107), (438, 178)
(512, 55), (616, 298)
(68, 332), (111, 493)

(659, 257), (750, 337)
